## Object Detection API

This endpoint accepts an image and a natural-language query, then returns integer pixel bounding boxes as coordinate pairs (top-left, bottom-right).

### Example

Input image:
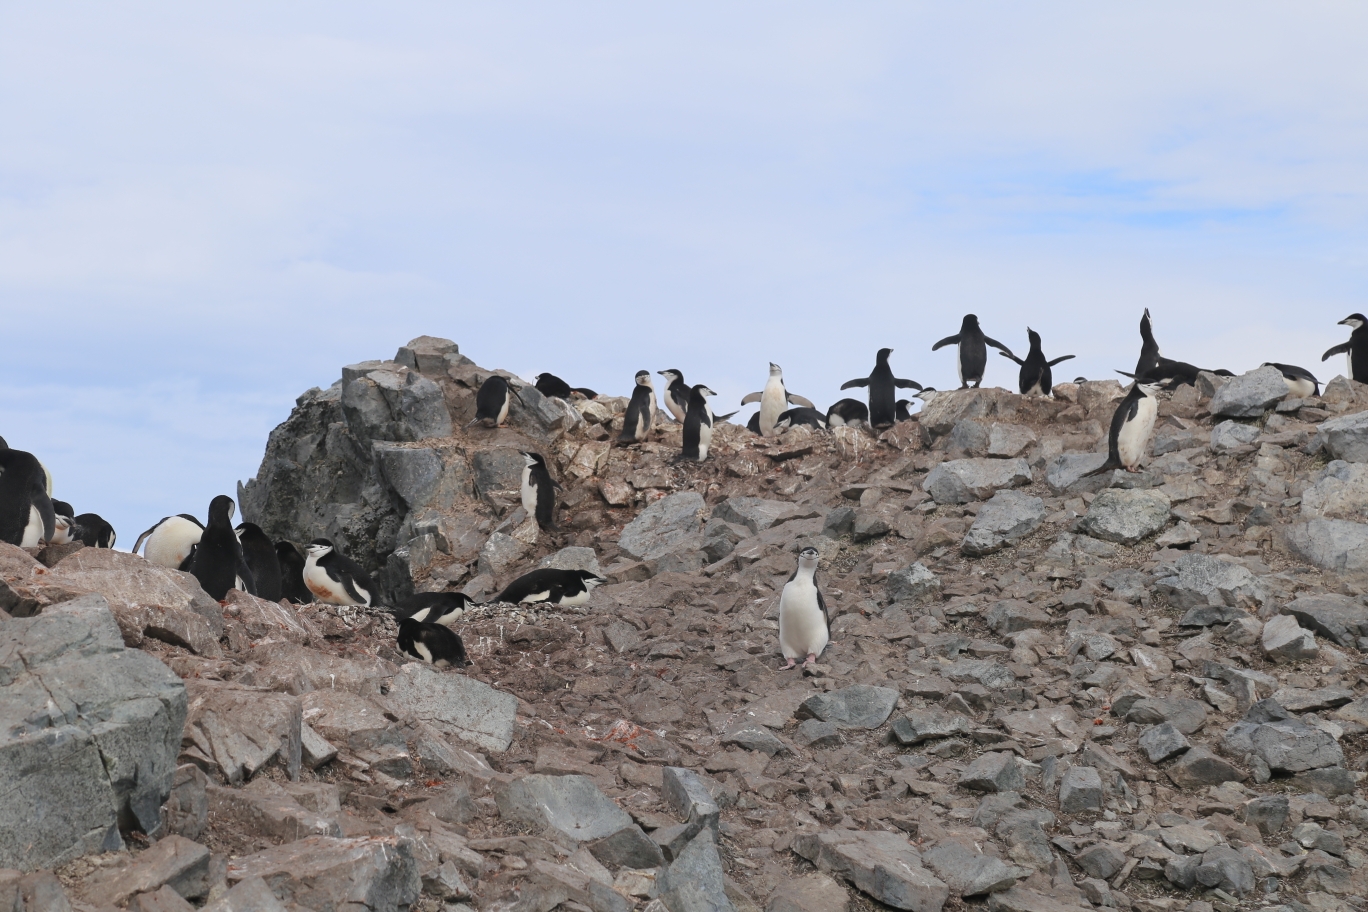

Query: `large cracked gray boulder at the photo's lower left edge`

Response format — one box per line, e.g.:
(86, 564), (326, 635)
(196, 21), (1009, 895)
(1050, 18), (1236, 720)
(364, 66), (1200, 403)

(0, 595), (186, 871)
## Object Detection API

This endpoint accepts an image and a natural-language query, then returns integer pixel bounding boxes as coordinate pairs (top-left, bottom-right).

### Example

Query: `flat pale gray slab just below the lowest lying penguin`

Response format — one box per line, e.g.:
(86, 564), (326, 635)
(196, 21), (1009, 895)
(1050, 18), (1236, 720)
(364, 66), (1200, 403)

(386, 662), (517, 751)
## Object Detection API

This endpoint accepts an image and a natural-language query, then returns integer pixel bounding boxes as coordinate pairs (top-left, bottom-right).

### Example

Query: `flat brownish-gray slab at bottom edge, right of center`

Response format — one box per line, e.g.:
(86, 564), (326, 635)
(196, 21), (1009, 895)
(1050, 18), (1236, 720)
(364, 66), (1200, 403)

(793, 830), (949, 912)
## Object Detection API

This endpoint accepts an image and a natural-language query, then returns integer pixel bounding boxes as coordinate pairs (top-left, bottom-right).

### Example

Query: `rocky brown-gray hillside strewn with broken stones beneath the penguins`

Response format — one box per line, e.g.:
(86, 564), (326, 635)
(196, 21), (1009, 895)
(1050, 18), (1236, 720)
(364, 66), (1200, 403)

(8, 338), (1368, 912)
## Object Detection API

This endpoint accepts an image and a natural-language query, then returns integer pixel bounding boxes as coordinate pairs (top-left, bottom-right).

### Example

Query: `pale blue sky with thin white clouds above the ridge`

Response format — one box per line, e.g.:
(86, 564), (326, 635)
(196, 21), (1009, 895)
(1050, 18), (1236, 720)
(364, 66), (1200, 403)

(0, 0), (1368, 547)
